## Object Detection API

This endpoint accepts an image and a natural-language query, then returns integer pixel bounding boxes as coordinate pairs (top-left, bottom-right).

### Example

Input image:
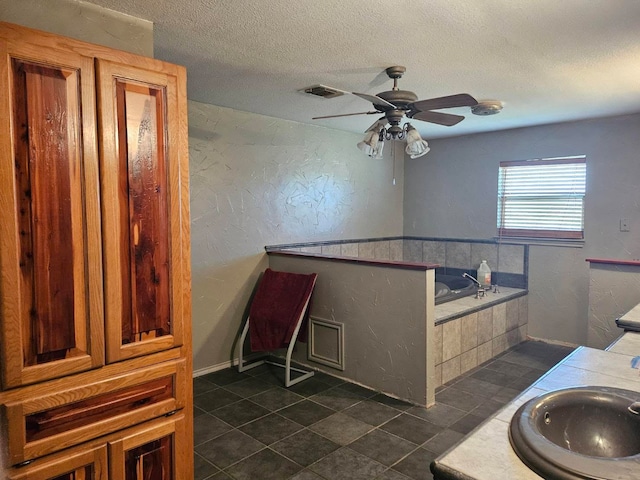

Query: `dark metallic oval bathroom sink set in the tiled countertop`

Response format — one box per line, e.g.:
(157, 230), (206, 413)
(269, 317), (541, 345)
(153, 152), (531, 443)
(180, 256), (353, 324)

(509, 382), (640, 480)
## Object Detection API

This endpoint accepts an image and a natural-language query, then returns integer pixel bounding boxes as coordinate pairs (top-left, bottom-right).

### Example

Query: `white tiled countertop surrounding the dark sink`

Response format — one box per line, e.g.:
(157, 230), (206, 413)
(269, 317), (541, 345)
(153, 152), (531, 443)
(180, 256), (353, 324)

(436, 332), (640, 480)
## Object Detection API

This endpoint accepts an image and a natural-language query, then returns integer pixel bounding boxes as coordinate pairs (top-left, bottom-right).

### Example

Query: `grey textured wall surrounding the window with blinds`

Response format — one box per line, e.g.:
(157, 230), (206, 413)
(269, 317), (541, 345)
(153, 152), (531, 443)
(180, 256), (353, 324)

(404, 115), (640, 344)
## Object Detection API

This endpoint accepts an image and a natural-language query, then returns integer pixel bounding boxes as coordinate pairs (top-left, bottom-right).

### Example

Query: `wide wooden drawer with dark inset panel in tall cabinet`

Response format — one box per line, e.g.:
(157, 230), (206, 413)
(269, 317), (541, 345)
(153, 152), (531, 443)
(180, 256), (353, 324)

(5, 359), (188, 465)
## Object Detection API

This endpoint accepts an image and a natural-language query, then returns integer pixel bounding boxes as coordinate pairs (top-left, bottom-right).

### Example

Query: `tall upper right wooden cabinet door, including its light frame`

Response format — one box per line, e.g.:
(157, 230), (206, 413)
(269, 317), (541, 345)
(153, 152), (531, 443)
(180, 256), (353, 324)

(97, 60), (188, 363)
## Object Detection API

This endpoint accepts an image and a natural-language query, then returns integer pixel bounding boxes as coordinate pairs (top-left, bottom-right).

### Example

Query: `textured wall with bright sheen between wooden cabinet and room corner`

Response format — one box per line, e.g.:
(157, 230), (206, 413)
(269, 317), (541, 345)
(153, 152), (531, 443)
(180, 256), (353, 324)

(189, 102), (403, 370)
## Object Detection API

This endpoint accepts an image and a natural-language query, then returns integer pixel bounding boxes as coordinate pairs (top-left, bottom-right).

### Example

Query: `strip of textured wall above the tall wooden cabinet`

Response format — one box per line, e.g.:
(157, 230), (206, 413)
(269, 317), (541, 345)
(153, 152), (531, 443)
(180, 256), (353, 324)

(0, 0), (153, 57)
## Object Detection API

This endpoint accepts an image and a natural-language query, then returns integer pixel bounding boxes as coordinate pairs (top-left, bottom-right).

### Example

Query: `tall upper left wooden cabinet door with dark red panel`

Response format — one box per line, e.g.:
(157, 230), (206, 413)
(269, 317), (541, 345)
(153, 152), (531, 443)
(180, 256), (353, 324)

(0, 26), (104, 389)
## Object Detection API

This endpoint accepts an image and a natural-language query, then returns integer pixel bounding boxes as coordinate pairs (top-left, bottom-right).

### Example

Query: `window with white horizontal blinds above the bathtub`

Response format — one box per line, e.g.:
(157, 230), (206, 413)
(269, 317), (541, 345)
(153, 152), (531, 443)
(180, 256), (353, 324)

(498, 156), (586, 239)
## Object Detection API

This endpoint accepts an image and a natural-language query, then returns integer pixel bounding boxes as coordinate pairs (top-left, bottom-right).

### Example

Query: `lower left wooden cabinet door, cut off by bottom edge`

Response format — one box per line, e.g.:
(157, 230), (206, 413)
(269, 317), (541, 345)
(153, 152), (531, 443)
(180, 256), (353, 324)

(8, 445), (109, 480)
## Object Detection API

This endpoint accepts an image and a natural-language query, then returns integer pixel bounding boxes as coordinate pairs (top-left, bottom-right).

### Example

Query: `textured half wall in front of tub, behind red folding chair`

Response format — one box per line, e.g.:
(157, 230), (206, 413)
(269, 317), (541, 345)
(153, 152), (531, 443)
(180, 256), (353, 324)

(269, 255), (436, 405)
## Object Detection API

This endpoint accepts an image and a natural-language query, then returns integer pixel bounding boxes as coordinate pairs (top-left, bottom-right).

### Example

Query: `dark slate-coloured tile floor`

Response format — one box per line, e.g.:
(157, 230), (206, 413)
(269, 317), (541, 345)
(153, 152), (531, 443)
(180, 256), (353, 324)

(194, 341), (572, 480)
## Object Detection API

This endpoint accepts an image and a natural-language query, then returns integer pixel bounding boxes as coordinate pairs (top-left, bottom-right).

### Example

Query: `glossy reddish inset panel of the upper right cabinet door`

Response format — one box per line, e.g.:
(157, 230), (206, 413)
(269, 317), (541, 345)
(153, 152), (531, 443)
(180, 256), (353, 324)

(116, 79), (171, 344)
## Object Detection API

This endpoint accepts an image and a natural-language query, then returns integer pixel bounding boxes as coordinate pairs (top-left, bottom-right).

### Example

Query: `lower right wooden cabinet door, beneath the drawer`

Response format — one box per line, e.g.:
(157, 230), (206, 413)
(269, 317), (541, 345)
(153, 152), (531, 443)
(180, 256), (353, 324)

(109, 414), (188, 480)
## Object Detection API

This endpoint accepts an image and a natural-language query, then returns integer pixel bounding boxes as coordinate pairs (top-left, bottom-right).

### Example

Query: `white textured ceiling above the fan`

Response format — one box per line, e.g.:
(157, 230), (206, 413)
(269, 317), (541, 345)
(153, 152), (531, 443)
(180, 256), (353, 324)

(85, 0), (640, 138)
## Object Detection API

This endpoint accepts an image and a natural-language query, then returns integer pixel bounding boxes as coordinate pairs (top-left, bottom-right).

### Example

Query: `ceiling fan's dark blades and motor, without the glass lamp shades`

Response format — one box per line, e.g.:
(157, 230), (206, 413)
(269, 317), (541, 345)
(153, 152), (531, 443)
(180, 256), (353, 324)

(312, 66), (478, 138)
